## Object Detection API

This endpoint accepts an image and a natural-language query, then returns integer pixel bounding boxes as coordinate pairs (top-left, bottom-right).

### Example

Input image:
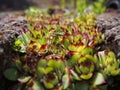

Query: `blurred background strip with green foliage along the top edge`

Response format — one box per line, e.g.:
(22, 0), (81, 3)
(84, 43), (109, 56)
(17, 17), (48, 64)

(0, 0), (120, 11)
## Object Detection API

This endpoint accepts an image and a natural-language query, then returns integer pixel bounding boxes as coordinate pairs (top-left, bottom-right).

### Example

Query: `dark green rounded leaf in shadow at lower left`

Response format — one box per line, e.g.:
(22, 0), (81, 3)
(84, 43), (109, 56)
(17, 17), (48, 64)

(4, 68), (18, 81)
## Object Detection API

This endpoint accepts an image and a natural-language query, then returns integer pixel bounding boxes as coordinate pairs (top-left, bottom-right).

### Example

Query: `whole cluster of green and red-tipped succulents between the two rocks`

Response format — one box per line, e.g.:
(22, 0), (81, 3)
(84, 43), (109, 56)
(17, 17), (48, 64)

(4, 7), (120, 90)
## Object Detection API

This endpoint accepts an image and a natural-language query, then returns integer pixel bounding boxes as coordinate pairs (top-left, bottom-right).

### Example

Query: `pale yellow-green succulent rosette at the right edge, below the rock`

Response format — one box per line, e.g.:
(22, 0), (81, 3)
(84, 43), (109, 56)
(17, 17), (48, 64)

(98, 51), (120, 76)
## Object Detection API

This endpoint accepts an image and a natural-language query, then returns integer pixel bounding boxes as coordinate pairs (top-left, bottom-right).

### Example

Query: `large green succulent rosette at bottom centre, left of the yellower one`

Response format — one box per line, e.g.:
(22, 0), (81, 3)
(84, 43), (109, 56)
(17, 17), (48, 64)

(37, 55), (70, 90)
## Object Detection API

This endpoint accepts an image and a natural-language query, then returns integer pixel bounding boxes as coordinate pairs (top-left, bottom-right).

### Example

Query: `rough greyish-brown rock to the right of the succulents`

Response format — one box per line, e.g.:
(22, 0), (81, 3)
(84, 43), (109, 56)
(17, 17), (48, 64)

(97, 10), (120, 58)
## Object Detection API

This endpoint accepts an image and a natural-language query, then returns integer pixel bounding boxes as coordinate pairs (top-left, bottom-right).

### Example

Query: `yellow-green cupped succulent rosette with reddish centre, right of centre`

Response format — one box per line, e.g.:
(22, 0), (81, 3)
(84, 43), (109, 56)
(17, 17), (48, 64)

(68, 45), (96, 80)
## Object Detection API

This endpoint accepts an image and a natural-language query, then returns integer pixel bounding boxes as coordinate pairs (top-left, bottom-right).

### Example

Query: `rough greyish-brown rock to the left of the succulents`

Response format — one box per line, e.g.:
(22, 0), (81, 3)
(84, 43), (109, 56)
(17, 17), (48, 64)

(0, 12), (27, 90)
